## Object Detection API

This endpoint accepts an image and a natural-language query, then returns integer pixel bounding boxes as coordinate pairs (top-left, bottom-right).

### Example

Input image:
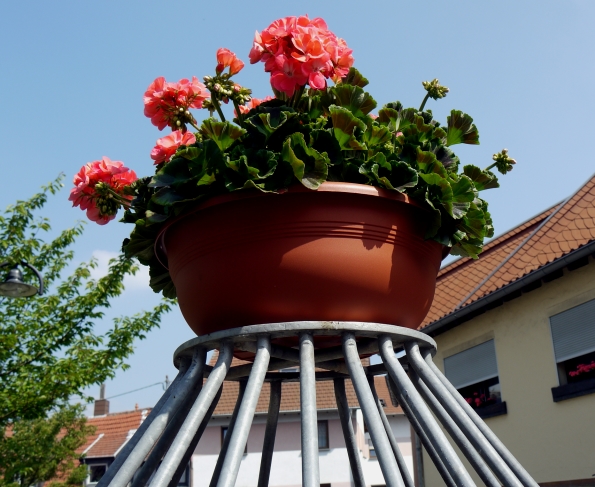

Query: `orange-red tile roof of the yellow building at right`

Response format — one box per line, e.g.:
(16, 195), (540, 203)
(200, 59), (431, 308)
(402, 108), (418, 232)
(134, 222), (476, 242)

(420, 176), (595, 329)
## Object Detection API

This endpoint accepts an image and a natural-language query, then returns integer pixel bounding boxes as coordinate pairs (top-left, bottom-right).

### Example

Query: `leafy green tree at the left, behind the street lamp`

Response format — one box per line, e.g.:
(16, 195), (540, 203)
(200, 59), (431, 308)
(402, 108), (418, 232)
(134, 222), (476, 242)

(0, 176), (172, 485)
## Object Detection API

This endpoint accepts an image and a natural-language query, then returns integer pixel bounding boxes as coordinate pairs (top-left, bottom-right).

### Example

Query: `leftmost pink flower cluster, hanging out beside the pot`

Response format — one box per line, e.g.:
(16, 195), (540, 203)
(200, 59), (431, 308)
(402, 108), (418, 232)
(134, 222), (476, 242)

(68, 156), (138, 225)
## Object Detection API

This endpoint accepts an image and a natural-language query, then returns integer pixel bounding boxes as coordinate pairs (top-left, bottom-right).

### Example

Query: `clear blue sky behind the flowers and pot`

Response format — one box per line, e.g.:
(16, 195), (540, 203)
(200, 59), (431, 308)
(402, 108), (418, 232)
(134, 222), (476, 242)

(0, 0), (595, 411)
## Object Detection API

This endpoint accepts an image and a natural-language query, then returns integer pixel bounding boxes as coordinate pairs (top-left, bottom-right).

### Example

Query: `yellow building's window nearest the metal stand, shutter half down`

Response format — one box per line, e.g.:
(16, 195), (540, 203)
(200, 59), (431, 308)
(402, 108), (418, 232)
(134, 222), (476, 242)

(444, 340), (506, 418)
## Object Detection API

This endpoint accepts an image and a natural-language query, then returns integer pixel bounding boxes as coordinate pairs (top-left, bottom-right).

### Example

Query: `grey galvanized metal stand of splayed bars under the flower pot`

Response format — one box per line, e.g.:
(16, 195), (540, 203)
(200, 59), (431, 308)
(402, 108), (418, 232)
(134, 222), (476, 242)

(97, 322), (537, 487)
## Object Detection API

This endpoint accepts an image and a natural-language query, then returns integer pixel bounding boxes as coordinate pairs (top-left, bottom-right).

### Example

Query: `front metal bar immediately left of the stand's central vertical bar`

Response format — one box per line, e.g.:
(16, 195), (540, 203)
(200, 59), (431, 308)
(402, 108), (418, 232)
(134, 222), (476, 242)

(217, 335), (271, 487)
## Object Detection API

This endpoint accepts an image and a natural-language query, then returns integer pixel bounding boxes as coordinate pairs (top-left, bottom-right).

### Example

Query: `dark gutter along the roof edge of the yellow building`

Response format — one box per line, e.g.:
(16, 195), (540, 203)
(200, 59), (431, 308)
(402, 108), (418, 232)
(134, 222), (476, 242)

(419, 240), (595, 337)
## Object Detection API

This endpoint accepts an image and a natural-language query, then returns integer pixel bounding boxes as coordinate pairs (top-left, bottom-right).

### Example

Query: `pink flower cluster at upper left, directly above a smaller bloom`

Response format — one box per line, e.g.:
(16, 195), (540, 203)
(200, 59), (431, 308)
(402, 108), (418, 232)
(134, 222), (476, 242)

(144, 76), (210, 130)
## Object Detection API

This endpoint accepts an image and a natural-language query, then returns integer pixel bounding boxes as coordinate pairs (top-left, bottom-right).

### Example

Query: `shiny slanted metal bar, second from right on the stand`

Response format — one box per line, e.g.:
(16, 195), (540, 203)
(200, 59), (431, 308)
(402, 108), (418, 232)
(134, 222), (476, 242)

(405, 342), (522, 487)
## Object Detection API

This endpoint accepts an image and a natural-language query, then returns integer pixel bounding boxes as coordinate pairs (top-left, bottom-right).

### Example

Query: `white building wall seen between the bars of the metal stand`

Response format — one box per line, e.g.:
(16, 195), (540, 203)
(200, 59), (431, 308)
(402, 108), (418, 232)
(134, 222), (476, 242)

(191, 410), (413, 487)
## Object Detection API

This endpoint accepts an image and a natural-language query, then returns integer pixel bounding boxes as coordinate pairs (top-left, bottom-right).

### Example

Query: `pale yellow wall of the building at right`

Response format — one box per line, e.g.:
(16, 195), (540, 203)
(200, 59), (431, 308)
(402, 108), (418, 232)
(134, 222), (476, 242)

(423, 260), (595, 487)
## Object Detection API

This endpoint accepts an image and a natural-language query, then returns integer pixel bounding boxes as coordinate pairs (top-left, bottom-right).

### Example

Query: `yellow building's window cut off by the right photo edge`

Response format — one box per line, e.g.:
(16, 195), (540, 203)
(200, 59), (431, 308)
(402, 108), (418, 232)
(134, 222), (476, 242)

(550, 299), (595, 401)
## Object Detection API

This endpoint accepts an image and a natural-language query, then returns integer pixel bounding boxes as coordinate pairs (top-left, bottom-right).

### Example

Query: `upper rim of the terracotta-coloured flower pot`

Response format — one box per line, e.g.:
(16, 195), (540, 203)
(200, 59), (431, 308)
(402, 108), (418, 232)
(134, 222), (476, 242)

(154, 181), (438, 270)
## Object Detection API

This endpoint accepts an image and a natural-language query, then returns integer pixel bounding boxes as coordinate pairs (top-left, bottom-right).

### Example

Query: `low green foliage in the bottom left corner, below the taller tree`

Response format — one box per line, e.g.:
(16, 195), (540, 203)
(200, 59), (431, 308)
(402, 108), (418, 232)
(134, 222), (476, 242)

(0, 405), (95, 487)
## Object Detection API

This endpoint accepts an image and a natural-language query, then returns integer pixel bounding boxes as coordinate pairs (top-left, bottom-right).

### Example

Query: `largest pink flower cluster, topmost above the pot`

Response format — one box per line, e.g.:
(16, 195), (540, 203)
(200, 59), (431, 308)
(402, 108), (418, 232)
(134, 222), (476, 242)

(250, 15), (353, 96)
